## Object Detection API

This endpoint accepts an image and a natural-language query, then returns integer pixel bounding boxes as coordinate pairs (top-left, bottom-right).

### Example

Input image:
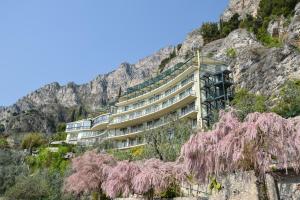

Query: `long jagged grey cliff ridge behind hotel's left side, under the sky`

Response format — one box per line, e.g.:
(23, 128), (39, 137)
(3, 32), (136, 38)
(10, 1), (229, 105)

(0, 46), (174, 133)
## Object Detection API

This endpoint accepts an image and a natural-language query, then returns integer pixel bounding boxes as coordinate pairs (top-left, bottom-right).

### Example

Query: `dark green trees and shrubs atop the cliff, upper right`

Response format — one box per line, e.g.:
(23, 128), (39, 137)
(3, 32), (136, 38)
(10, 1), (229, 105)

(196, 0), (300, 47)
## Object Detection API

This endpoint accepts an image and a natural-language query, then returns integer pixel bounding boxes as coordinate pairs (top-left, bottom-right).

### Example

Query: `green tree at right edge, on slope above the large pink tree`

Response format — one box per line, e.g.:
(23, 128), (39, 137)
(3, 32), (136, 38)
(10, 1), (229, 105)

(273, 80), (300, 118)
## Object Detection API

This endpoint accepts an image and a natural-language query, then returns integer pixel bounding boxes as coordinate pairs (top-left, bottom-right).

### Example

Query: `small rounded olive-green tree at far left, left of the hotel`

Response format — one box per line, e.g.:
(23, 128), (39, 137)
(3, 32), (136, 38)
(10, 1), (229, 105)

(22, 133), (46, 153)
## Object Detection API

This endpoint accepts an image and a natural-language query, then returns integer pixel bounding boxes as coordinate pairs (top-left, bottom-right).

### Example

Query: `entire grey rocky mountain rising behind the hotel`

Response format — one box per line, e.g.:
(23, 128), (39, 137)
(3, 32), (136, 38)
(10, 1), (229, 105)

(0, 0), (300, 133)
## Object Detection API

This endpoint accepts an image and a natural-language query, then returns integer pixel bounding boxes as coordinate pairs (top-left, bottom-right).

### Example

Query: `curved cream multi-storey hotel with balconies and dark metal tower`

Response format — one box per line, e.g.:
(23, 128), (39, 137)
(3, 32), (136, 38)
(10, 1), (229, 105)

(66, 53), (233, 149)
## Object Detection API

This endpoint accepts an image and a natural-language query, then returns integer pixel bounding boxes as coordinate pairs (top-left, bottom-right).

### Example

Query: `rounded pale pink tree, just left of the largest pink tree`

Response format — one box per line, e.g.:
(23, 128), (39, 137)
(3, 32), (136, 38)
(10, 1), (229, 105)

(132, 159), (182, 199)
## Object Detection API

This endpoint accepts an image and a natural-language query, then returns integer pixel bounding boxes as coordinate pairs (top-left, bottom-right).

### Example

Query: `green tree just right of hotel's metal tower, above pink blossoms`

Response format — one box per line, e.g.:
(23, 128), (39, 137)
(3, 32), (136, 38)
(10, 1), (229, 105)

(231, 89), (268, 118)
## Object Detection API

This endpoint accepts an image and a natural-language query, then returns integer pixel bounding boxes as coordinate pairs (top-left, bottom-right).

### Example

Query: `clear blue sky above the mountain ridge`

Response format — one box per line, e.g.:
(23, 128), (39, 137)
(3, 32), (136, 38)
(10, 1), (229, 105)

(0, 0), (228, 106)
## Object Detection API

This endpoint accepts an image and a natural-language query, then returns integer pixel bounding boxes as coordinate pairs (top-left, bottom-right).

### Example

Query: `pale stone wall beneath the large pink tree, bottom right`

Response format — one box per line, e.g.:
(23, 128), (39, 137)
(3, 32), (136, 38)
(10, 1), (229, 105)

(118, 171), (300, 200)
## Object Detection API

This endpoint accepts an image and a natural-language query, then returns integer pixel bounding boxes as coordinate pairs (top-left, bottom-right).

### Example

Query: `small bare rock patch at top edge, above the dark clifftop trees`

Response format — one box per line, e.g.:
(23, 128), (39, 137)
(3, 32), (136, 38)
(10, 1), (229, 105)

(221, 0), (260, 21)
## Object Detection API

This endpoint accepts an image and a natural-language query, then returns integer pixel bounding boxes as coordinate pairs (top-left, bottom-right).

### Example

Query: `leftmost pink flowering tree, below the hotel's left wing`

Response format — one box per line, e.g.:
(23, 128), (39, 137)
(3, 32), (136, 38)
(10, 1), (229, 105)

(64, 151), (116, 196)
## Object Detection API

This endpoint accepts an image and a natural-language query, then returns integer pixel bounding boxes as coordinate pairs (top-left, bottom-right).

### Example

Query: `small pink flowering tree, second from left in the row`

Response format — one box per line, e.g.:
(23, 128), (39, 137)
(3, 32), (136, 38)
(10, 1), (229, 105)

(102, 161), (140, 198)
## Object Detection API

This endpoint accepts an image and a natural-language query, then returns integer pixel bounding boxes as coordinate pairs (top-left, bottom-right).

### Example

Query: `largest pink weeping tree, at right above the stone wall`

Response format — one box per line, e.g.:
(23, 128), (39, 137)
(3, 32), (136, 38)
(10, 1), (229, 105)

(181, 110), (300, 181)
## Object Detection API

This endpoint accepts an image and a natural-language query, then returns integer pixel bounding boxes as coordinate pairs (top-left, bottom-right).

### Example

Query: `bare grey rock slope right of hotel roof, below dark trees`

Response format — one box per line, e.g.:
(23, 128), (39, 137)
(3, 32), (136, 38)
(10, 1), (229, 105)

(203, 26), (300, 96)
